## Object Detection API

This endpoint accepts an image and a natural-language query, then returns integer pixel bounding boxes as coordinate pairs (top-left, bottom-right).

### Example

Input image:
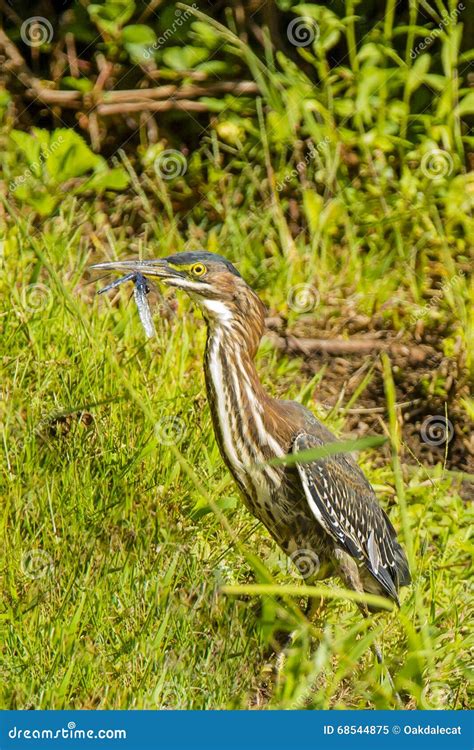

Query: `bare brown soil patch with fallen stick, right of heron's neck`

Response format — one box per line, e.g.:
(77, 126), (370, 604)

(267, 315), (474, 488)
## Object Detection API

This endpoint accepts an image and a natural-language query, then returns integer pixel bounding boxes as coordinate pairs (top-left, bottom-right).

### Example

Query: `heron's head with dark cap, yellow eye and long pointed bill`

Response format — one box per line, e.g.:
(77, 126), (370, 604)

(92, 252), (264, 327)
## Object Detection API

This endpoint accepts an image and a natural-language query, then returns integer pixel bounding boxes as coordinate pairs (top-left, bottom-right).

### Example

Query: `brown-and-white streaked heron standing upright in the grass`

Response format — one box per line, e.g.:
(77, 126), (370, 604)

(93, 252), (410, 616)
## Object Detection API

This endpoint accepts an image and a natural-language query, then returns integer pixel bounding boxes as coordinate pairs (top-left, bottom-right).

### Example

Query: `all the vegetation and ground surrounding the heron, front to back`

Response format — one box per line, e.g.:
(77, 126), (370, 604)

(0, 0), (474, 708)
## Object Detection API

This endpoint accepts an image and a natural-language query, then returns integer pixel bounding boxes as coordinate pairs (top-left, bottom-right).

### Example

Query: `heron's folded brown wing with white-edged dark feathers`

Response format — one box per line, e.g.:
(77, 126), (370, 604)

(293, 433), (408, 602)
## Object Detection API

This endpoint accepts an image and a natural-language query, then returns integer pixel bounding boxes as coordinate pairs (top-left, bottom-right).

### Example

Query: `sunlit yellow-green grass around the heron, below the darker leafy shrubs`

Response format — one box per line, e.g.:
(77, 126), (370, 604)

(0, 185), (472, 709)
